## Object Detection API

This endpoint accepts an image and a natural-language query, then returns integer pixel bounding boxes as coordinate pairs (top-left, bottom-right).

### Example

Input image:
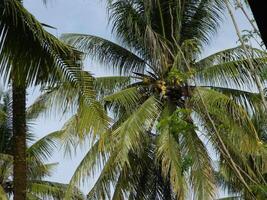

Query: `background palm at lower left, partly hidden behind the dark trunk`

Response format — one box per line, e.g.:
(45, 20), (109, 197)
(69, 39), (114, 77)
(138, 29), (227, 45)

(0, 92), (84, 200)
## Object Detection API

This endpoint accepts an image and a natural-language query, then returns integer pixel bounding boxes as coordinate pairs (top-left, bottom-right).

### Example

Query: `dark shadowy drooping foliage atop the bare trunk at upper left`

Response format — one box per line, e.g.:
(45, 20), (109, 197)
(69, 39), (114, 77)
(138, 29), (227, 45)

(0, 0), (80, 85)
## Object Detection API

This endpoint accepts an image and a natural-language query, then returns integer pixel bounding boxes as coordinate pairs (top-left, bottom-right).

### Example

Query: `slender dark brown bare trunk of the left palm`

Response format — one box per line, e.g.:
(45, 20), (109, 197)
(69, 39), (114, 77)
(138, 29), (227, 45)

(12, 83), (27, 200)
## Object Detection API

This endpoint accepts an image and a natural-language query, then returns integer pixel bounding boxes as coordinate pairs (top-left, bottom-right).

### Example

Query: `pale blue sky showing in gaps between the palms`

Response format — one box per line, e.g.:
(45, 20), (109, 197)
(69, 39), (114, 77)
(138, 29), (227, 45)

(24, 0), (258, 197)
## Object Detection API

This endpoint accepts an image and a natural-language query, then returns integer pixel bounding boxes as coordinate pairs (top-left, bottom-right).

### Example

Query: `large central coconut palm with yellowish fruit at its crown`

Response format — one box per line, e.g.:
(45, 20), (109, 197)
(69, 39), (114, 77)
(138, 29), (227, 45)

(59, 0), (266, 200)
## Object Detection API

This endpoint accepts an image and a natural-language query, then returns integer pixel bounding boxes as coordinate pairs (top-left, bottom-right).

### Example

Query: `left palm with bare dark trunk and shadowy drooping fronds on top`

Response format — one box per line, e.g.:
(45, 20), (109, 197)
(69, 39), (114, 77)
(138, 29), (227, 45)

(0, 0), (98, 200)
